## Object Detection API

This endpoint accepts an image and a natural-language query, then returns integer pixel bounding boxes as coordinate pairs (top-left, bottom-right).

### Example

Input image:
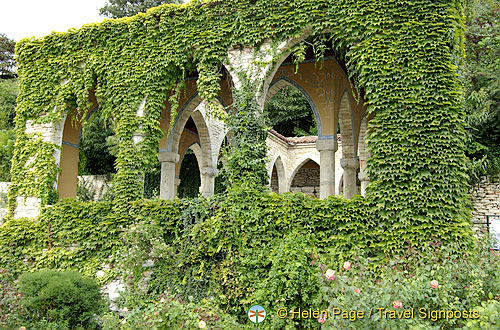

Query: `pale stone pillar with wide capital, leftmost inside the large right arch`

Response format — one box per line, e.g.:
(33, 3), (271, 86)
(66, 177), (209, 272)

(316, 138), (338, 199)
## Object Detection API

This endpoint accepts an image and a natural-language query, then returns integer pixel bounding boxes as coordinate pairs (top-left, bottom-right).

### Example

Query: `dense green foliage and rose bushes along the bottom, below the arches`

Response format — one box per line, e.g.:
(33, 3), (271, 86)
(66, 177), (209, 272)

(0, 196), (500, 329)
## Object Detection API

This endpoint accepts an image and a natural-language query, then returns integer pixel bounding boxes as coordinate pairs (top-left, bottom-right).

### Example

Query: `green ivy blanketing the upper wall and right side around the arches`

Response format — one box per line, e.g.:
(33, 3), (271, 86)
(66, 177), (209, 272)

(10, 0), (470, 253)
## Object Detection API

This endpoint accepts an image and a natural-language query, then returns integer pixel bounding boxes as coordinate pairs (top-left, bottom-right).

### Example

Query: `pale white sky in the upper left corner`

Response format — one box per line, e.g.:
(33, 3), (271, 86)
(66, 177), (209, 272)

(0, 0), (107, 41)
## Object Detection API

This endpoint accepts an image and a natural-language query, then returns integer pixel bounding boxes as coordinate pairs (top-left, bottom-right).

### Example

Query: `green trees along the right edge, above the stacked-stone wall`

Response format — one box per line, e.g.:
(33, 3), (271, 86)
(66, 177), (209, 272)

(465, 0), (500, 181)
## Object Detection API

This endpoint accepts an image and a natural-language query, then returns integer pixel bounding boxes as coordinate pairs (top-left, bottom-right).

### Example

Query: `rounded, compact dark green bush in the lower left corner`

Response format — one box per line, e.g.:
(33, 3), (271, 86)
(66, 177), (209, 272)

(19, 270), (105, 329)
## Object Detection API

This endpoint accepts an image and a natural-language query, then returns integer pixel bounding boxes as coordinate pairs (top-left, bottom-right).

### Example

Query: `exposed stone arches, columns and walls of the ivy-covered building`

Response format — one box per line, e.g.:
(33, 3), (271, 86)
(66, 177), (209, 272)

(15, 32), (369, 217)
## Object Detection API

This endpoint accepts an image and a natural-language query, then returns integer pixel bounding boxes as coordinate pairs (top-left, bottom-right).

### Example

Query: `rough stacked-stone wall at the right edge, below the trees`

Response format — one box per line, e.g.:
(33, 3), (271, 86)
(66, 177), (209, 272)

(470, 178), (500, 226)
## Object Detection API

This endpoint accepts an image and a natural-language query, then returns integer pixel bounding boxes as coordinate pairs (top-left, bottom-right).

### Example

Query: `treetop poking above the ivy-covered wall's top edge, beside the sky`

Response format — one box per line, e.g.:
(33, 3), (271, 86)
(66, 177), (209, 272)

(99, 0), (184, 18)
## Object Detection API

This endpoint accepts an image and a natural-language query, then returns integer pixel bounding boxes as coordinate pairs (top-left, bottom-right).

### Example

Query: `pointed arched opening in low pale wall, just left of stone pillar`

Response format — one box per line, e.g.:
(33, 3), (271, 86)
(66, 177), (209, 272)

(290, 159), (320, 198)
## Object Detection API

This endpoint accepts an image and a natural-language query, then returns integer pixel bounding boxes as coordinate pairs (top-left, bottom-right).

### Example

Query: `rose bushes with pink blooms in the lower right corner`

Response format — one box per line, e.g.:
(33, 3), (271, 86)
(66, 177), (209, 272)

(323, 239), (500, 329)
